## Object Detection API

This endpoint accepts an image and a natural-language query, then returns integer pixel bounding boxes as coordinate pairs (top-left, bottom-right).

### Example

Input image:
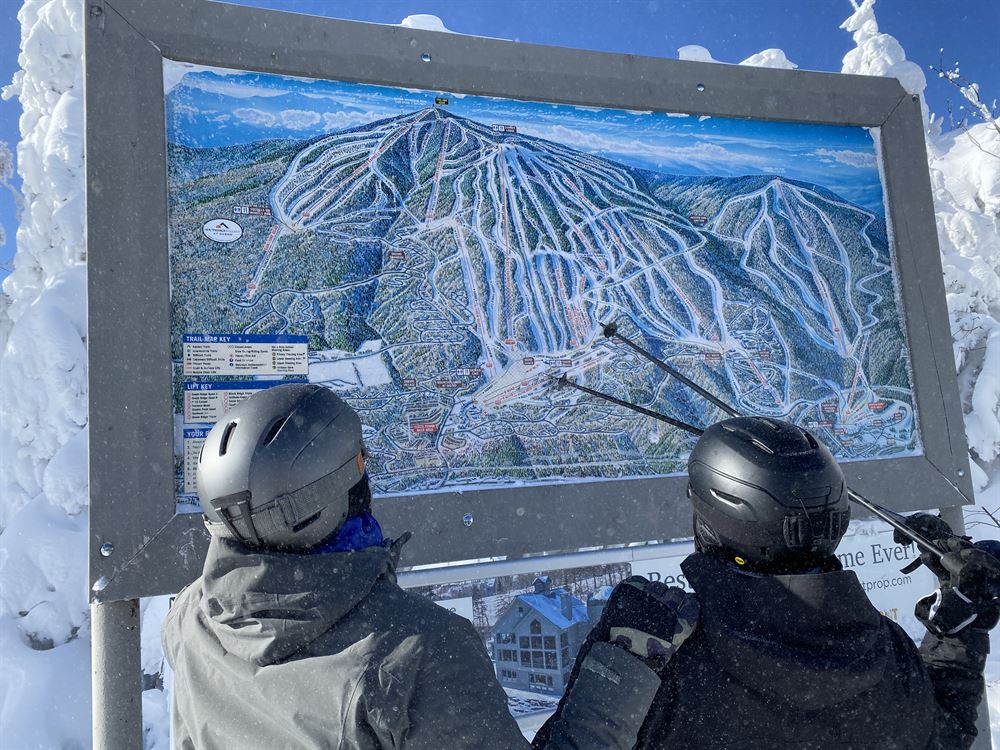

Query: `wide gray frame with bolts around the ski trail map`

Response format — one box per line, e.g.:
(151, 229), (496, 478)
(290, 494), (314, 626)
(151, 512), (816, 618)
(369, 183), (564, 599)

(86, 0), (973, 601)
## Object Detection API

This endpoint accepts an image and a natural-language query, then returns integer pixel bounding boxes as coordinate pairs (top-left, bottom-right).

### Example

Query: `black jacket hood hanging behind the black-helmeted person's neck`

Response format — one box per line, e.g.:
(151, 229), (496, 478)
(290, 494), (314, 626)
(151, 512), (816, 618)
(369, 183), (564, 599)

(681, 554), (891, 710)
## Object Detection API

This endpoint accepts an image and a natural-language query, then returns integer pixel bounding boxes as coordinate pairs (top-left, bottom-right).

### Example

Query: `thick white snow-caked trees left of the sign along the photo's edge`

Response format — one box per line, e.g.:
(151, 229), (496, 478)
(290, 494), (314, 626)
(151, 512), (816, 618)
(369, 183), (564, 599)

(0, 0), (90, 747)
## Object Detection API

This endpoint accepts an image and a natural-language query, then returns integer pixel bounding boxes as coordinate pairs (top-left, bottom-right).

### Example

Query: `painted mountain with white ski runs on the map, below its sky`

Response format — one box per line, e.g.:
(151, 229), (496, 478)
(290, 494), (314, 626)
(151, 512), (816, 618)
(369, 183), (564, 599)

(168, 106), (920, 494)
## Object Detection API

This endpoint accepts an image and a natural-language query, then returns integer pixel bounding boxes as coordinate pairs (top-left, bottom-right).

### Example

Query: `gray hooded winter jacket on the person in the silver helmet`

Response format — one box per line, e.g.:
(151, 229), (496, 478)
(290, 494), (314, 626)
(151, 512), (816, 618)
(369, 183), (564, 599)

(163, 539), (660, 750)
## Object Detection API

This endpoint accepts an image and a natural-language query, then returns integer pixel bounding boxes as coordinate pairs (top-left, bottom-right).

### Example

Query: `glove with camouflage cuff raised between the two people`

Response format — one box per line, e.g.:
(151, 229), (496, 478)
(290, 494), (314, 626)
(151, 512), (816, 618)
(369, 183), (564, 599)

(594, 576), (700, 671)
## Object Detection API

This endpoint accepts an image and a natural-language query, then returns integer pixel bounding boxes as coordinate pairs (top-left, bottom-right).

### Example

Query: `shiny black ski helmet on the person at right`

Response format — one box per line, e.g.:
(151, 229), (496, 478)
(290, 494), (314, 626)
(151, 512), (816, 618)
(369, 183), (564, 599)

(688, 417), (851, 566)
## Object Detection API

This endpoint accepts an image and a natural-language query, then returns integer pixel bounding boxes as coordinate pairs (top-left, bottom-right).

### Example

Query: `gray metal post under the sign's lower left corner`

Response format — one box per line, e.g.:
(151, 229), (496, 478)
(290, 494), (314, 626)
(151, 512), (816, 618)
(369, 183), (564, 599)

(90, 599), (142, 750)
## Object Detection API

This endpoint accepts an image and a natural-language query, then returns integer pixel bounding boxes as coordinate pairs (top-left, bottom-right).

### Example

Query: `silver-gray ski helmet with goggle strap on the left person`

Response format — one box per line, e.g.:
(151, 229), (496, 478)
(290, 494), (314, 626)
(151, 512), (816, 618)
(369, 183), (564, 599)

(198, 383), (365, 551)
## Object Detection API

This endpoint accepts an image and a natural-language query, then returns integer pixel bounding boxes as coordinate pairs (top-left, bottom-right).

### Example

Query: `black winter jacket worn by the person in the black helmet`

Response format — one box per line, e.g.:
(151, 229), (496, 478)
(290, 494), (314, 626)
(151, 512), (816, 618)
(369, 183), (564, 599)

(536, 554), (988, 750)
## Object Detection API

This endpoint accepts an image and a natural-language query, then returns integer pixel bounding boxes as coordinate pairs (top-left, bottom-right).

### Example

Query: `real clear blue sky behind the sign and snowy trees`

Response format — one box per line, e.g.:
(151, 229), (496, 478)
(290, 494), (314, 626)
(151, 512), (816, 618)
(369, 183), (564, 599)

(0, 0), (1000, 286)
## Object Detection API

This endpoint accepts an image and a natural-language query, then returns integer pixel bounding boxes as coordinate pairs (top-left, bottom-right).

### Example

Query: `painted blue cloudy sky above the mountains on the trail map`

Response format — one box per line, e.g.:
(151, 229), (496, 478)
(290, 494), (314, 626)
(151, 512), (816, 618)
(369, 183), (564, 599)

(164, 61), (884, 214)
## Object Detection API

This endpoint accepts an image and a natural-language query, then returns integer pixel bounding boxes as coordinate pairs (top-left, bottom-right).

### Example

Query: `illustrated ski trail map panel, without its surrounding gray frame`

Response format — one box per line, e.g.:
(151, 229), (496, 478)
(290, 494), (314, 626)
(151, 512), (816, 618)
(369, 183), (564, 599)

(164, 60), (922, 508)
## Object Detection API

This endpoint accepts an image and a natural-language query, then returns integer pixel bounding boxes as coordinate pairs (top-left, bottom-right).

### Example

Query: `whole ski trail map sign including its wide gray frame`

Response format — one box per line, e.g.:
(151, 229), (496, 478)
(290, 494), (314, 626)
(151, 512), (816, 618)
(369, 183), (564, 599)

(87, 0), (972, 600)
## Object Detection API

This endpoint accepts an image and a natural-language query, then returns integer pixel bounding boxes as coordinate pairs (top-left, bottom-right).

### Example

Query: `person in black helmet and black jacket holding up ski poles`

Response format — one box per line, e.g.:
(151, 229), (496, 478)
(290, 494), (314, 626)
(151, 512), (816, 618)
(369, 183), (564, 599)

(540, 417), (1000, 750)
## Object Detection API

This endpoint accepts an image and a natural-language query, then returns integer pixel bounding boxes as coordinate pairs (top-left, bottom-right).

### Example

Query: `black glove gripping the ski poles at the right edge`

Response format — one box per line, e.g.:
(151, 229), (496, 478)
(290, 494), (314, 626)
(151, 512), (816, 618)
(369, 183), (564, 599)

(914, 537), (1000, 637)
